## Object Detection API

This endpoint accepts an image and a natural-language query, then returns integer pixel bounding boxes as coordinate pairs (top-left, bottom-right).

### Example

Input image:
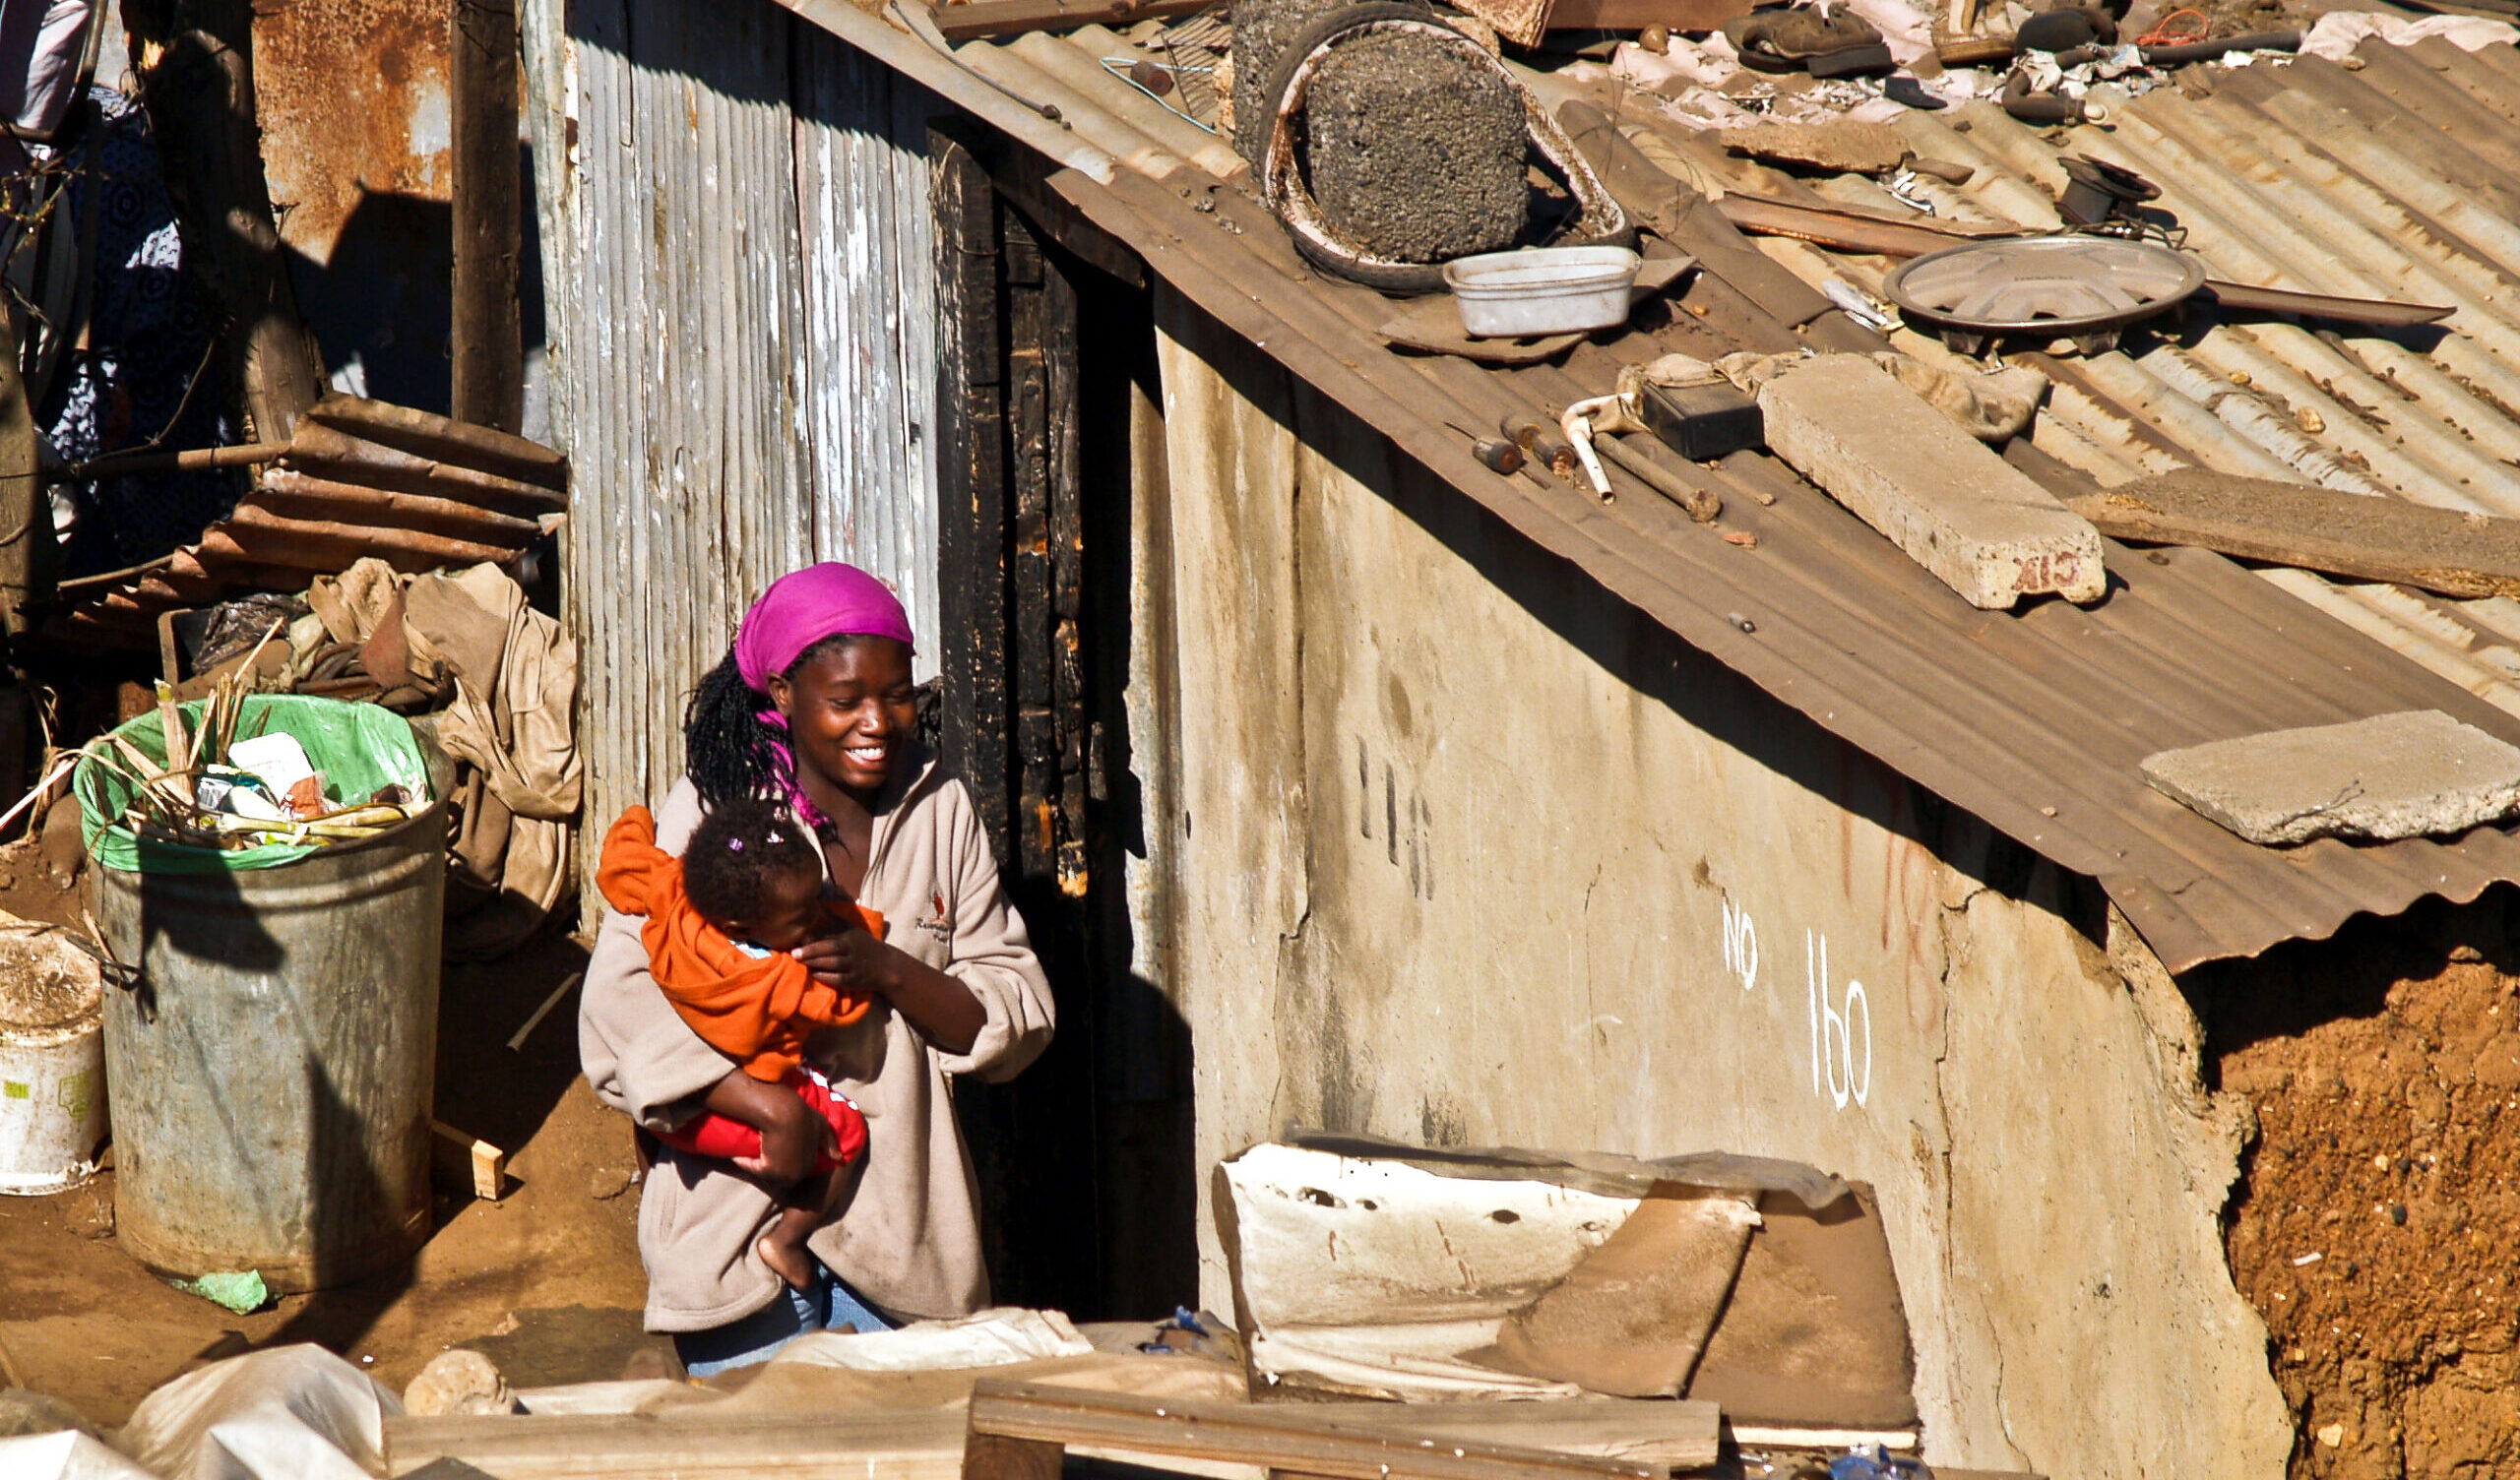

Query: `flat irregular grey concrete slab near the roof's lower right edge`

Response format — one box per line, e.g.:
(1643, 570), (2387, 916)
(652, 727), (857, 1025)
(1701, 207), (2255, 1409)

(2142, 709), (2520, 843)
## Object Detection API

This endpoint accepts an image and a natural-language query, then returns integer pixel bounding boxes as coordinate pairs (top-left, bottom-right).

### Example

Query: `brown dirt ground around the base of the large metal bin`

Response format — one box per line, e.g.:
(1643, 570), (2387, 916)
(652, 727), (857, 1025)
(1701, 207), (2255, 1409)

(0, 838), (661, 1425)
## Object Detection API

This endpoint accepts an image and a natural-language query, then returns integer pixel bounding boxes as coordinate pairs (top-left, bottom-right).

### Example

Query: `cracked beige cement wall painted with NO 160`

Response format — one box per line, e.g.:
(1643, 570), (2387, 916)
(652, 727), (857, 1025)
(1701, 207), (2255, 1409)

(1131, 282), (2291, 1477)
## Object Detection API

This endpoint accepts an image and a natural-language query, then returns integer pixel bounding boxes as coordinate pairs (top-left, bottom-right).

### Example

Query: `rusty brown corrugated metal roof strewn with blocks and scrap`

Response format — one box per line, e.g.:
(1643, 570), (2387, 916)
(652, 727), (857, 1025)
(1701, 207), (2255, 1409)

(771, 0), (2520, 969)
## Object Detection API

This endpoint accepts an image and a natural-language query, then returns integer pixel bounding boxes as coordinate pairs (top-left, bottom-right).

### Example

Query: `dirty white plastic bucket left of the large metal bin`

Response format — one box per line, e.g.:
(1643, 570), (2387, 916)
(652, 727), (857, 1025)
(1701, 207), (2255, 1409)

(0, 913), (106, 1196)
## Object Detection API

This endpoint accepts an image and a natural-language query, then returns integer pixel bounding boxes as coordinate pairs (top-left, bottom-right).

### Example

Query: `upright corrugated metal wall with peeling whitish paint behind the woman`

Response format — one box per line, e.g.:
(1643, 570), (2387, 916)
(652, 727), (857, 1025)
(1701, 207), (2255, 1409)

(524, 0), (948, 850)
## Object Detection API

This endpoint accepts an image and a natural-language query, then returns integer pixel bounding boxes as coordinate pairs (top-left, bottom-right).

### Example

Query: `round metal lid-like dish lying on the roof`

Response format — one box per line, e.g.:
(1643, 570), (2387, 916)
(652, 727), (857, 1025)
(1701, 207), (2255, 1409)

(1882, 234), (2205, 355)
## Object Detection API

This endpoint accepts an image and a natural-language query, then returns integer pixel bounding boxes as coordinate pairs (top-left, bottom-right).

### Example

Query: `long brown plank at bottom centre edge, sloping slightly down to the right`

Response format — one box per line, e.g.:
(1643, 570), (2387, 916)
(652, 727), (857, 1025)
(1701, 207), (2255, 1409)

(965, 1382), (1669, 1480)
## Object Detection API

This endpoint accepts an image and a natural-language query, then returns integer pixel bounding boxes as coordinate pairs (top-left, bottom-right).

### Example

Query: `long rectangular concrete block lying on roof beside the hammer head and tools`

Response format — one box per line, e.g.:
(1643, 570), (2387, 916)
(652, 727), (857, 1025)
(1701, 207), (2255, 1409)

(1759, 355), (2110, 609)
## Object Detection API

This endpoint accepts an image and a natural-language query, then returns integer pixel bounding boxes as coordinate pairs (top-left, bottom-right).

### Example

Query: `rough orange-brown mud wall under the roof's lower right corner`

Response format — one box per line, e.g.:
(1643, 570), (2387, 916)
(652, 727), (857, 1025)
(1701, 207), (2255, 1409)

(2200, 891), (2520, 1480)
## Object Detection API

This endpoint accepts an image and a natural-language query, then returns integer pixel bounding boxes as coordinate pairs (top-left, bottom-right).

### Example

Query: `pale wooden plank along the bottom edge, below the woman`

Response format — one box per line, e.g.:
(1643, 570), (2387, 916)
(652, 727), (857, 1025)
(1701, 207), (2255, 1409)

(386, 1407), (963, 1480)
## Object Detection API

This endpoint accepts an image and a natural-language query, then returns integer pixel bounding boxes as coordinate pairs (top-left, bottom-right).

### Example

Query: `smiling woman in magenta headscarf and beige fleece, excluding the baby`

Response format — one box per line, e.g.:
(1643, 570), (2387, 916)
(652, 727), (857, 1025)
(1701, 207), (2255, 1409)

(580, 564), (1053, 1375)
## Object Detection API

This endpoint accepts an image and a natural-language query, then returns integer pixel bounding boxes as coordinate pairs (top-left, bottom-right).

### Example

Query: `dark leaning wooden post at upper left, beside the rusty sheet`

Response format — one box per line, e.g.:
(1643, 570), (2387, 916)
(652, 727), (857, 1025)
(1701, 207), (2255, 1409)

(134, 0), (323, 443)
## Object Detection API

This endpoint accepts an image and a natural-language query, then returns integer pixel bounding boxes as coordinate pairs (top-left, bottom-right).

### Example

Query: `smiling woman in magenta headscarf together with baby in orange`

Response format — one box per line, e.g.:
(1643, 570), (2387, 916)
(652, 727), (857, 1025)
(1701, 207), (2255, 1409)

(580, 564), (1053, 1377)
